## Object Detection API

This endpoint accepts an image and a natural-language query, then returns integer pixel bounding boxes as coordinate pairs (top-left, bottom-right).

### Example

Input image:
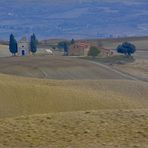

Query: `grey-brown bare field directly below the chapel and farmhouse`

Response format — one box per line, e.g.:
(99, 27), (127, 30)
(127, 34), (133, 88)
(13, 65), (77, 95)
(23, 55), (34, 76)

(0, 55), (129, 80)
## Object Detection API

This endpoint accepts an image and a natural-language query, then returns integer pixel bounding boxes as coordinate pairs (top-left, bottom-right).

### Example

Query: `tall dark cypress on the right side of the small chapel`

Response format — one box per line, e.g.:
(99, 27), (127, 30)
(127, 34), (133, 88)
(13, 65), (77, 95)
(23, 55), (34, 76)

(30, 34), (38, 54)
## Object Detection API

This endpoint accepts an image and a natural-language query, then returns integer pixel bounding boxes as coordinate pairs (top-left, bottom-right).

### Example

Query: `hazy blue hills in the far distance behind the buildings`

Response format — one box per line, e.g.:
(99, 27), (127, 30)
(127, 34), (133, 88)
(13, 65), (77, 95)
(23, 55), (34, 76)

(0, 0), (148, 39)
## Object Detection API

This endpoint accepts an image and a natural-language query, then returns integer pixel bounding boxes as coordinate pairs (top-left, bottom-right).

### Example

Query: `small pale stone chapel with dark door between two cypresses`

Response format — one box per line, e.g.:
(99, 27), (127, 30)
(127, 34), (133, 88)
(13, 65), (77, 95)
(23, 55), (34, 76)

(18, 37), (30, 56)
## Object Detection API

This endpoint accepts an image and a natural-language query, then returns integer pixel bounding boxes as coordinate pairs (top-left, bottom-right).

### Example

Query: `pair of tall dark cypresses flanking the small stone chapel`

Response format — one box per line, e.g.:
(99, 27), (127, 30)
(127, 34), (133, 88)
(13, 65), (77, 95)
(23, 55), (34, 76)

(9, 34), (38, 56)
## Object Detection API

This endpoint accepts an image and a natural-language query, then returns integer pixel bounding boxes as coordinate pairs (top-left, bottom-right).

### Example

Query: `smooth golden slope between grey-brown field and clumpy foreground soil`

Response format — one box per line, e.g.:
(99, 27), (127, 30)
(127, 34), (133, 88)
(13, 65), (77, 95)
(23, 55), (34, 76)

(0, 75), (148, 118)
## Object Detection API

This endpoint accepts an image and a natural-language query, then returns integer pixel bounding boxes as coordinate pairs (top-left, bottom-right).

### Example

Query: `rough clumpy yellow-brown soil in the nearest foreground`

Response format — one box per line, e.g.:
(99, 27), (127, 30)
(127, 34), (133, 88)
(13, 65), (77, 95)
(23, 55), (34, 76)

(0, 110), (148, 148)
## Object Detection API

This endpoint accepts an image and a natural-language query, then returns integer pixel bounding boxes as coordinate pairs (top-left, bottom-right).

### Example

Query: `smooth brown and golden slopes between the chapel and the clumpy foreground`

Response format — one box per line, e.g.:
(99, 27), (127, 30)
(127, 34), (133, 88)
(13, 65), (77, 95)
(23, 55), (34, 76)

(0, 56), (148, 117)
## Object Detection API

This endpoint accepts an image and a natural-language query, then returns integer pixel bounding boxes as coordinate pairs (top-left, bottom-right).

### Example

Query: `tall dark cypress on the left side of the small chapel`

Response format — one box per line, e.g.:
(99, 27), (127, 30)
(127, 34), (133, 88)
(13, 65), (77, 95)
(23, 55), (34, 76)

(9, 34), (18, 56)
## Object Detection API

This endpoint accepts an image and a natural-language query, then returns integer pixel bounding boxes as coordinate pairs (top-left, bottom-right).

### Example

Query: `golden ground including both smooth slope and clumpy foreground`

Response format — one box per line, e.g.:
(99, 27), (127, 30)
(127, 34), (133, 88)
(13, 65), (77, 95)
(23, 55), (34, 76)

(0, 75), (148, 148)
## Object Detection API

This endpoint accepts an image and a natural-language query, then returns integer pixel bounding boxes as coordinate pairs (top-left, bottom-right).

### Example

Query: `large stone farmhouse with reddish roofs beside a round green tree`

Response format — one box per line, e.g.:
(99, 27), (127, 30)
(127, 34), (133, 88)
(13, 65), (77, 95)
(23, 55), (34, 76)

(68, 42), (90, 56)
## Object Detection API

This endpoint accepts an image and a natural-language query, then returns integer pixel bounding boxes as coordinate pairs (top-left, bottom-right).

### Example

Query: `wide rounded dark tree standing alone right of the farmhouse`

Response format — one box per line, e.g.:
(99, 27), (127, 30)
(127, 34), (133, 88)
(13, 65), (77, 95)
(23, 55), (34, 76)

(117, 42), (136, 56)
